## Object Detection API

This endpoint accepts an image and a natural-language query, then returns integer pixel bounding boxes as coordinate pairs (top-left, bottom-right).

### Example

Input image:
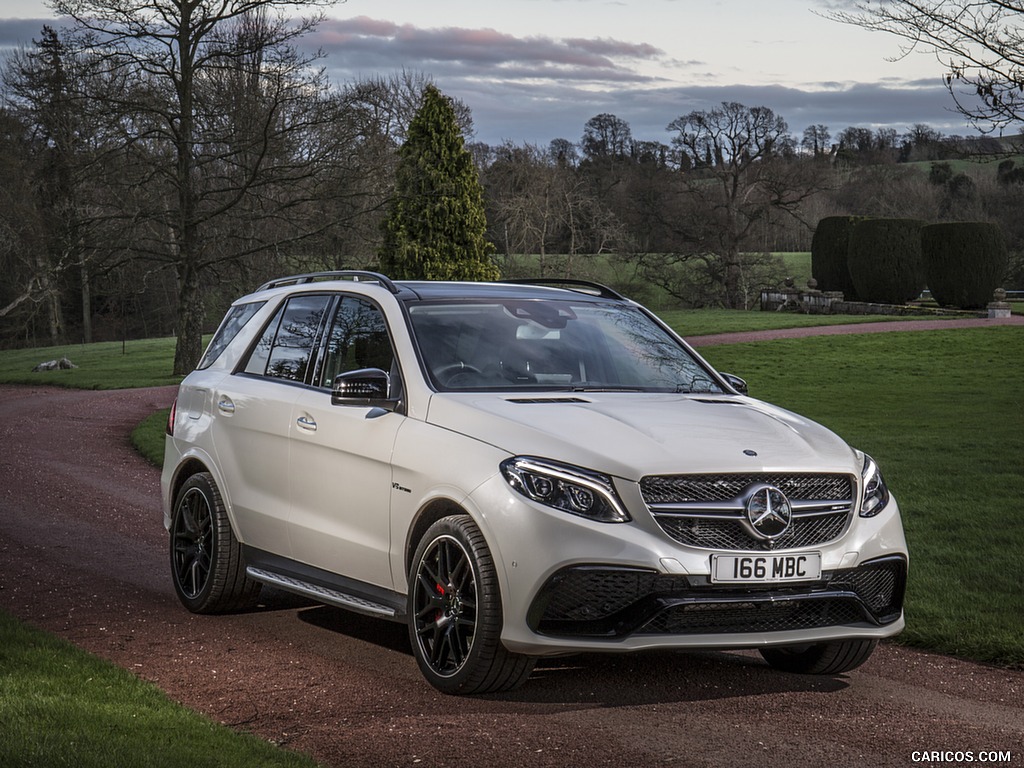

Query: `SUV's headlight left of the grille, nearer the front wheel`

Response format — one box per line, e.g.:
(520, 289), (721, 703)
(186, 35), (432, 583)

(501, 456), (630, 522)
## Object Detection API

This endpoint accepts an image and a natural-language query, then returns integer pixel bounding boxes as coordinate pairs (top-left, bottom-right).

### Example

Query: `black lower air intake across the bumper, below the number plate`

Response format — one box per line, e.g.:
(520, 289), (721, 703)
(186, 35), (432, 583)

(528, 556), (906, 638)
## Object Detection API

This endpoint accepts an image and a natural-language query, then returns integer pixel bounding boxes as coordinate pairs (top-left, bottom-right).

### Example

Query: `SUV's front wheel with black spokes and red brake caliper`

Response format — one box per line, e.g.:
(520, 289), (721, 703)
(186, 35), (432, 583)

(409, 515), (535, 694)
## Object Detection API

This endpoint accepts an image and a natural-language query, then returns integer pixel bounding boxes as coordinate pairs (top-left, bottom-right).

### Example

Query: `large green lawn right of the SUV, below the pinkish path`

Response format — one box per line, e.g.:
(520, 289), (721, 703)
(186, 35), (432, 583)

(700, 327), (1024, 667)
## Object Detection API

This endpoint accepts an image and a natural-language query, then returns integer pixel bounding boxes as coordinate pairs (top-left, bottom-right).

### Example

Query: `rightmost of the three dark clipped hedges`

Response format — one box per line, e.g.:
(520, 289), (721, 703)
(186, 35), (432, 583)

(921, 221), (1009, 309)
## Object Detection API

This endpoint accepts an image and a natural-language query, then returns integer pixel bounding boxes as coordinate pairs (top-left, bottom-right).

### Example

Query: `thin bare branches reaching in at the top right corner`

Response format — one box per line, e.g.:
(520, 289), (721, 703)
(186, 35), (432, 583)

(826, 0), (1024, 130)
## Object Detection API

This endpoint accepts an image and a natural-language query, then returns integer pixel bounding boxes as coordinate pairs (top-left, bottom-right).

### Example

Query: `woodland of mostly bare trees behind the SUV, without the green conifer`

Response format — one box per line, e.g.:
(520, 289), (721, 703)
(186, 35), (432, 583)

(0, 0), (1024, 373)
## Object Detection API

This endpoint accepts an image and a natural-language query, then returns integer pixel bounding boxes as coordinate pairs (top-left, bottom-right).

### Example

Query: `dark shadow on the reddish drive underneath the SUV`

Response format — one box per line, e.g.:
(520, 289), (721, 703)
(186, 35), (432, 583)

(286, 603), (850, 709)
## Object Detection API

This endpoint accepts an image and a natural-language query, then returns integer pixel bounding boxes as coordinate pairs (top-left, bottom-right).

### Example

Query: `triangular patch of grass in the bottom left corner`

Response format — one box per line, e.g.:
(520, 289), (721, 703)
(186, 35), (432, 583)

(0, 611), (315, 768)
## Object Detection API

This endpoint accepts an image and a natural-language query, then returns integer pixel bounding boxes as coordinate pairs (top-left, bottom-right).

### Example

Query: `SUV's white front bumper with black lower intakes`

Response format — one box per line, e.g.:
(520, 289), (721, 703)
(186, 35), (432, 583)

(467, 479), (907, 656)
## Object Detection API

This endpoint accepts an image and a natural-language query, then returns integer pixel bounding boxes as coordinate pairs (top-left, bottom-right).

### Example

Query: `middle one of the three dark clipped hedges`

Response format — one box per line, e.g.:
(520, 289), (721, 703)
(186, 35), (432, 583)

(847, 219), (928, 304)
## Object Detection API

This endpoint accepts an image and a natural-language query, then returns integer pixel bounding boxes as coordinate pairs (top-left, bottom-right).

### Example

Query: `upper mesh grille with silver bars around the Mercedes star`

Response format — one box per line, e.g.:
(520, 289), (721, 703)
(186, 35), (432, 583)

(640, 473), (855, 552)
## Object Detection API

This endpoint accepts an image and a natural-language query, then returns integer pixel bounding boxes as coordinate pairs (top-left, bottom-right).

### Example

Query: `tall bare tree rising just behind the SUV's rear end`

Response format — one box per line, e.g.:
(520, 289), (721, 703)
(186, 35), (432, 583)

(52, 0), (348, 374)
